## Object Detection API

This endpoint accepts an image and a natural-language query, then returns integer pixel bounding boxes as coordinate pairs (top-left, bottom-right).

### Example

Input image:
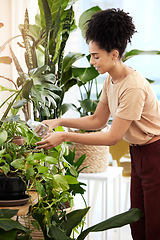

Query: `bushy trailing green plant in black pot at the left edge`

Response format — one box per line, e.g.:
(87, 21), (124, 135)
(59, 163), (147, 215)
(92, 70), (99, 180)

(0, 116), (40, 204)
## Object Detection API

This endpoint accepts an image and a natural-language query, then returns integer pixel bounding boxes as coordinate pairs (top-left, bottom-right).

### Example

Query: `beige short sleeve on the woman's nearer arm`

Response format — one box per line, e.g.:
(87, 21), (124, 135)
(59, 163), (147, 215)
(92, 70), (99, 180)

(116, 88), (146, 120)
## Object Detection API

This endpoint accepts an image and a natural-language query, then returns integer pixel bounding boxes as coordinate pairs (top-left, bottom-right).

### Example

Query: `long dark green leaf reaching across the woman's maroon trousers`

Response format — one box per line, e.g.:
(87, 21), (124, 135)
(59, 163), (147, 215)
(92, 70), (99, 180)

(77, 208), (143, 240)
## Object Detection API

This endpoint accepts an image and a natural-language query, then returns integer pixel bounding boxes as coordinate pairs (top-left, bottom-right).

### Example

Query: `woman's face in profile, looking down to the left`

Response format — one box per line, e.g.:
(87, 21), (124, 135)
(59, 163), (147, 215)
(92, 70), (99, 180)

(89, 41), (115, 74)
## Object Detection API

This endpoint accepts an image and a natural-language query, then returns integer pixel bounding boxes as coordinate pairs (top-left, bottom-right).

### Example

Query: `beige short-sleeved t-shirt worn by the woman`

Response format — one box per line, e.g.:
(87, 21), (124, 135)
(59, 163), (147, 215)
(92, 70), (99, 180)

(100, 71), (160, 145)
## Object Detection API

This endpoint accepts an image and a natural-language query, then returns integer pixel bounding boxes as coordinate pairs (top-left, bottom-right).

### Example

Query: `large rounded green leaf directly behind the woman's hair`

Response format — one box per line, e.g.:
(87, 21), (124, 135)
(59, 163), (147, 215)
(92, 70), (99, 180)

(79, 6), (101, 37)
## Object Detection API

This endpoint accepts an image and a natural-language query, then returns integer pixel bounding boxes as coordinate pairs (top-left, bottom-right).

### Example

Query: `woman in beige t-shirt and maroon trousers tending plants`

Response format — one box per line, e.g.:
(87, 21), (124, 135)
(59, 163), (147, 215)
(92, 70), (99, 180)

(37, 9), (160, 240)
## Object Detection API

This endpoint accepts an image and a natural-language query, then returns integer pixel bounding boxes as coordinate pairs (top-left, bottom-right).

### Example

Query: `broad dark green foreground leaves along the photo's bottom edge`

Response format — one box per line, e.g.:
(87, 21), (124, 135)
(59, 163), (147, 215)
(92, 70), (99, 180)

(0, 208), (143, 240)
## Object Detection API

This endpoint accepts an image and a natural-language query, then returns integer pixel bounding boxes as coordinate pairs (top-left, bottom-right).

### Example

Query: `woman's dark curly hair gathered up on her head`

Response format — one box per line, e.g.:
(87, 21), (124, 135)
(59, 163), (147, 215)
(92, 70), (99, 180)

(85, 8), (136, 58)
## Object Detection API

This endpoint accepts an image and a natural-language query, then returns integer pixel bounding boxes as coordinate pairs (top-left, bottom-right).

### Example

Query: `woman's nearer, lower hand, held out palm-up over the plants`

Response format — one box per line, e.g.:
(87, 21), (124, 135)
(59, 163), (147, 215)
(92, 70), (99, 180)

(36, 132), (63, 150)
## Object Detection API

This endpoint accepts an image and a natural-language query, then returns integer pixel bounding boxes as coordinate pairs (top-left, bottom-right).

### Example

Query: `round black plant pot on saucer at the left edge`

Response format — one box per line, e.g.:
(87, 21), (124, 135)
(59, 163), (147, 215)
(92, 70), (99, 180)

(0, 176), (26, 200)
